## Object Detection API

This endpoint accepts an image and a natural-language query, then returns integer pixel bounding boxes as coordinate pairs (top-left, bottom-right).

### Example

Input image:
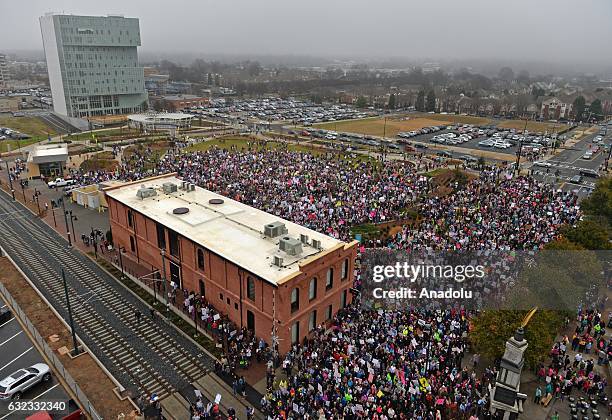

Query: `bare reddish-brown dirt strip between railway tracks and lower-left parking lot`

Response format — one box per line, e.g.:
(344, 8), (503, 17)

(0, 258), (136, 419)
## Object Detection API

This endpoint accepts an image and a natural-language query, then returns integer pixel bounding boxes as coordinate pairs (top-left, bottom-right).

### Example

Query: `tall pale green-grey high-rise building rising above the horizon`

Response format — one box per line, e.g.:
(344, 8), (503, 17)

(40, 14), (148, 118)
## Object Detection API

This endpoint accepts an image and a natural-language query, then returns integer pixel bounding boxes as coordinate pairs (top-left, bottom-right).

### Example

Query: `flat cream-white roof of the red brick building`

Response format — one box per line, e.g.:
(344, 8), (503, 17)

(104, 174), (347, 285)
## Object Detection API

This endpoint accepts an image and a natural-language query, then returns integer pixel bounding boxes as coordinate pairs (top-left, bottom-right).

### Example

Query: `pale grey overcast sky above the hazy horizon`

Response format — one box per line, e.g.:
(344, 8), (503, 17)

(0, 0), (612, 65)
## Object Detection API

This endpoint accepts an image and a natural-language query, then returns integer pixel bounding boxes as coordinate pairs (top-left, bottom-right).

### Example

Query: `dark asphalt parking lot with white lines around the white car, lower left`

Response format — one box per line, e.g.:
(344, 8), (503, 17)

(0, 299), (76, 420)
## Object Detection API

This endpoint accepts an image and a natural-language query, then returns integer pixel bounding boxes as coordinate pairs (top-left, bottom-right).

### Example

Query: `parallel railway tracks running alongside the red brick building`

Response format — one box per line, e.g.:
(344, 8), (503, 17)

(0, 192), (213, 398)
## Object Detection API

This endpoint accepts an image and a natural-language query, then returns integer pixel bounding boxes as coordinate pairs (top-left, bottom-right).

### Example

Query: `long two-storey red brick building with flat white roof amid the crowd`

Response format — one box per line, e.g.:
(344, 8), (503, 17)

(105, 174), (357, 353)
